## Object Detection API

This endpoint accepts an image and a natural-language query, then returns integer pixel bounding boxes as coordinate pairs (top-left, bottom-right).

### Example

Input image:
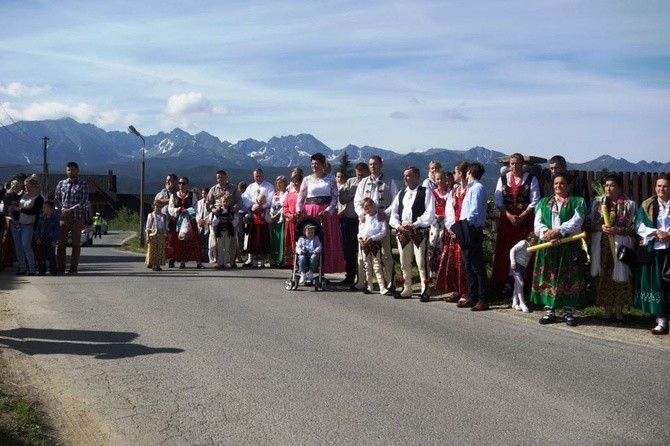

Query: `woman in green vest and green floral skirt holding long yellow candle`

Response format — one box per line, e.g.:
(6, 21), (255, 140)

(532, 173), (586, 326)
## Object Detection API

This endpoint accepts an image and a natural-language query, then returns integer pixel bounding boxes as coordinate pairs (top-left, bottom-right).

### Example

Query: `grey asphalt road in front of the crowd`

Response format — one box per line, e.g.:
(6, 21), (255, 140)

(0, 234), (670, 445)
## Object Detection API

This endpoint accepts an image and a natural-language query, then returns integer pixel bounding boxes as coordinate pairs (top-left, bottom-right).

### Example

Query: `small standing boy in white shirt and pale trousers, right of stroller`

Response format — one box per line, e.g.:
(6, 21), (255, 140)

(358, 197), (393, 296)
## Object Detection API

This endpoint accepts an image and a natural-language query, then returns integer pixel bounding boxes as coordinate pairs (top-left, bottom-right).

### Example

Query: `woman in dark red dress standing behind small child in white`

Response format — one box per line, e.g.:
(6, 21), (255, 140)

(492, 153), (540, 292)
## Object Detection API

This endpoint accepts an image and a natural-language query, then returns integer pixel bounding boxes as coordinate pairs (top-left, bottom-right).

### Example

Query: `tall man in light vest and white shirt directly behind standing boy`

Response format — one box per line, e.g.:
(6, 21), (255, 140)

(352, 155), (398, 291)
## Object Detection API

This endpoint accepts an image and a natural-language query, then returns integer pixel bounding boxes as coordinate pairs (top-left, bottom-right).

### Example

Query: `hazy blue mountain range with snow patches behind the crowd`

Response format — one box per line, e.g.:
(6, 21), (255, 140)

(0, 118), (670, 192)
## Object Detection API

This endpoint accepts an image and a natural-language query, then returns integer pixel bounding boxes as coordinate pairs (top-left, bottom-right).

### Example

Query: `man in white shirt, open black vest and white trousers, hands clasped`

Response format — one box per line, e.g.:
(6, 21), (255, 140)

(389, 166), (435, 302)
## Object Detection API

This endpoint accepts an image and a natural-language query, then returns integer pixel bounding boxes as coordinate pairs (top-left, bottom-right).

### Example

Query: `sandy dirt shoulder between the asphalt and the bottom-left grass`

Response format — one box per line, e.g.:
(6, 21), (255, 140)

(0, 292), (110, 446)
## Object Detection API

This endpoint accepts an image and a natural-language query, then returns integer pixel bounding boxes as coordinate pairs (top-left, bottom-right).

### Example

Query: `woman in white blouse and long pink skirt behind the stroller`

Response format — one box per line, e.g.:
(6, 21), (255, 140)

(296, 153), (344, 273)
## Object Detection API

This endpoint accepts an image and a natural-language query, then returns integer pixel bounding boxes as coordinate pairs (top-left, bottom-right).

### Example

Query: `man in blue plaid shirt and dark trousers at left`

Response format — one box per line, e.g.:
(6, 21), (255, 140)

(54, 161), (89, 274)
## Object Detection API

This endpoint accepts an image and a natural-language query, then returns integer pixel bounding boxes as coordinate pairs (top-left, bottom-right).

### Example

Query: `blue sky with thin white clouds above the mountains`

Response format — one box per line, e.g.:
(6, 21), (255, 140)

(0, 0), (670, 162)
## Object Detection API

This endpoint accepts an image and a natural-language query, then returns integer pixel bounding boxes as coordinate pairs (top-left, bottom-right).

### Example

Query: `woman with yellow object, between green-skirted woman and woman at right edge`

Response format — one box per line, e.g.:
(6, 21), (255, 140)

(589, 174), (637, 324)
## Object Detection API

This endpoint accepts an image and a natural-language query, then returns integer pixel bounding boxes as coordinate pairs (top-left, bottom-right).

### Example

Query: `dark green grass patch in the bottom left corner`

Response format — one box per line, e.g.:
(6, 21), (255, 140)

(0, 390), (58, 446)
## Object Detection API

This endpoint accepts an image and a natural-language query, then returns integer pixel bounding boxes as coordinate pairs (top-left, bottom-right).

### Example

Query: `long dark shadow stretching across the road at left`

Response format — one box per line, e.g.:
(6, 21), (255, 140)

(0, 328), (184, 359)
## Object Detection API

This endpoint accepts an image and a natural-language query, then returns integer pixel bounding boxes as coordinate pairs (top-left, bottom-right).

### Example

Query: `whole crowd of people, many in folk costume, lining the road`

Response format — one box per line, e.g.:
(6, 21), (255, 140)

(0, 153), (670, 334)
